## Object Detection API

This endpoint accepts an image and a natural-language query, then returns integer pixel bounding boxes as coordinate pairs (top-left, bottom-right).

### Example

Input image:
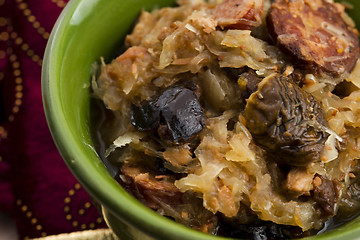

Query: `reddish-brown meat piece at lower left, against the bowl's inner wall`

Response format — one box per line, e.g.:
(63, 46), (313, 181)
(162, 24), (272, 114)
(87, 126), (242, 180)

(121, 164), (182, 210)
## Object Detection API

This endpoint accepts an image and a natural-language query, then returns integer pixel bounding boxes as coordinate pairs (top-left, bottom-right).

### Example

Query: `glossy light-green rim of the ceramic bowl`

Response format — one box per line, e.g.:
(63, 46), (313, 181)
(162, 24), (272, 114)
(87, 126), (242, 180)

(41, 0), (360, 240)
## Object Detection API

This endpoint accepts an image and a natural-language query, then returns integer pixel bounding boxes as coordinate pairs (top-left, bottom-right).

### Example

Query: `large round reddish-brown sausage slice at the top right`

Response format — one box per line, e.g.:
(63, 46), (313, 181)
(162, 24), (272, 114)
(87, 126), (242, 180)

(267, 0), (359, 76)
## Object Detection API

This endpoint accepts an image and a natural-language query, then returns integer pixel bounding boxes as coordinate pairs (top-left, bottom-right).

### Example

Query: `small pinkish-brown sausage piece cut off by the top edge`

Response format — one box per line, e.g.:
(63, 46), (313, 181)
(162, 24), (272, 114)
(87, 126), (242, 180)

(214, 0), (264, 30)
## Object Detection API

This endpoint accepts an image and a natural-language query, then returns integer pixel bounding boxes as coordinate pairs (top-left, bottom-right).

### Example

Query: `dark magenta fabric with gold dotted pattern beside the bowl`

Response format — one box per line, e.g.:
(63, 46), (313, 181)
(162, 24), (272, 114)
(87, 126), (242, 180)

(0, 0), (104, 239)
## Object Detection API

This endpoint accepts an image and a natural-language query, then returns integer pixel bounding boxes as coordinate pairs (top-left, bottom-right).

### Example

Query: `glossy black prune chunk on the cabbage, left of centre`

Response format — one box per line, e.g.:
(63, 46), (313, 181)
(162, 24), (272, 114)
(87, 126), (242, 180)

(131, 86), (206, 144)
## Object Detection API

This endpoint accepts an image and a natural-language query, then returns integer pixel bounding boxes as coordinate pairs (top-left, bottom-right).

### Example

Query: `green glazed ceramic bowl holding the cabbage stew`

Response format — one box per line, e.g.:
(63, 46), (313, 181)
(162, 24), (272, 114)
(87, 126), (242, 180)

(42, 0), (360, 240)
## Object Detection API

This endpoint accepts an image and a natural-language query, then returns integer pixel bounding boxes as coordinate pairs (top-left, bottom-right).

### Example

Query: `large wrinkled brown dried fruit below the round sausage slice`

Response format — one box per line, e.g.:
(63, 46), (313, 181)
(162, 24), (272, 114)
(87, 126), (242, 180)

(245, 75), (328, 166)
